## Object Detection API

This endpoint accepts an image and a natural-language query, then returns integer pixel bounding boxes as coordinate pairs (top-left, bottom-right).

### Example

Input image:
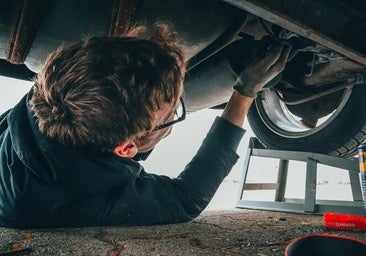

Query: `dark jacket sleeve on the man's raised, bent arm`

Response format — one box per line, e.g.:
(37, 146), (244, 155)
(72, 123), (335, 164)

(102, 117), (245, 225)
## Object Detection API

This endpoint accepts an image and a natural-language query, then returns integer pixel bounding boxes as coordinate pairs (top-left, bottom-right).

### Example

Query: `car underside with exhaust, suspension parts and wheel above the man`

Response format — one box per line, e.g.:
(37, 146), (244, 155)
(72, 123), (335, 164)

(0, 0), (366, 157)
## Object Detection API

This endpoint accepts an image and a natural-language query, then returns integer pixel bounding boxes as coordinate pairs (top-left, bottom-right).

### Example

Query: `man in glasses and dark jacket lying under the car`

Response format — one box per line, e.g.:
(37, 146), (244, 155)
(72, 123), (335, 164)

(0, 24), (290, 228)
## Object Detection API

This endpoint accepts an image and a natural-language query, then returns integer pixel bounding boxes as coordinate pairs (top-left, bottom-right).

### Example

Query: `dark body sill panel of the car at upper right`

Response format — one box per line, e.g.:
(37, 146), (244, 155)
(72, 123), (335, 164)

(224, 0), (366, 65)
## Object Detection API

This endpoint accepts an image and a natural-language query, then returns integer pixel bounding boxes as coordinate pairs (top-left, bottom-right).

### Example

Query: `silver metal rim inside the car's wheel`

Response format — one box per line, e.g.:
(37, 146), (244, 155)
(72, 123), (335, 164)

(255, 88), (352, 138)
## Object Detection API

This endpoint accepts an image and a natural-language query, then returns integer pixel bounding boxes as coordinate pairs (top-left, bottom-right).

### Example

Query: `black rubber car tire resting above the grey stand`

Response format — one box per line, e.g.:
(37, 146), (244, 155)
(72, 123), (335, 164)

(248, 85), (366, 157)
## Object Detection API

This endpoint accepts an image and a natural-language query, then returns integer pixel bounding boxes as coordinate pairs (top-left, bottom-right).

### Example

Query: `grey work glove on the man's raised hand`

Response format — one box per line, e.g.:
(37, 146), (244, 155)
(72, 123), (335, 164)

(233, 43), (291, 98)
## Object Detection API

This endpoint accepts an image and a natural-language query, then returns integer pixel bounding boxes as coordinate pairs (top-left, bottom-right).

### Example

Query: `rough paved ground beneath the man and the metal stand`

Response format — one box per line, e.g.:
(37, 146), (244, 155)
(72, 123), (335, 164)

(0, 210), (366, 256)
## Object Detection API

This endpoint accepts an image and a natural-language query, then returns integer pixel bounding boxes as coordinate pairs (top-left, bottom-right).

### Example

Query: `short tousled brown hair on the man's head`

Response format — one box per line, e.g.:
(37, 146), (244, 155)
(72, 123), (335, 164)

(30, 24), (185, 151)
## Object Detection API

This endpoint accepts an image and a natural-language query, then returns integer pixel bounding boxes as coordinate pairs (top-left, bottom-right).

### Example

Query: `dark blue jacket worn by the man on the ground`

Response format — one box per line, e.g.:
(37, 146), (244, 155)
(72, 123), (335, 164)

(0, 91), (244, 228)
